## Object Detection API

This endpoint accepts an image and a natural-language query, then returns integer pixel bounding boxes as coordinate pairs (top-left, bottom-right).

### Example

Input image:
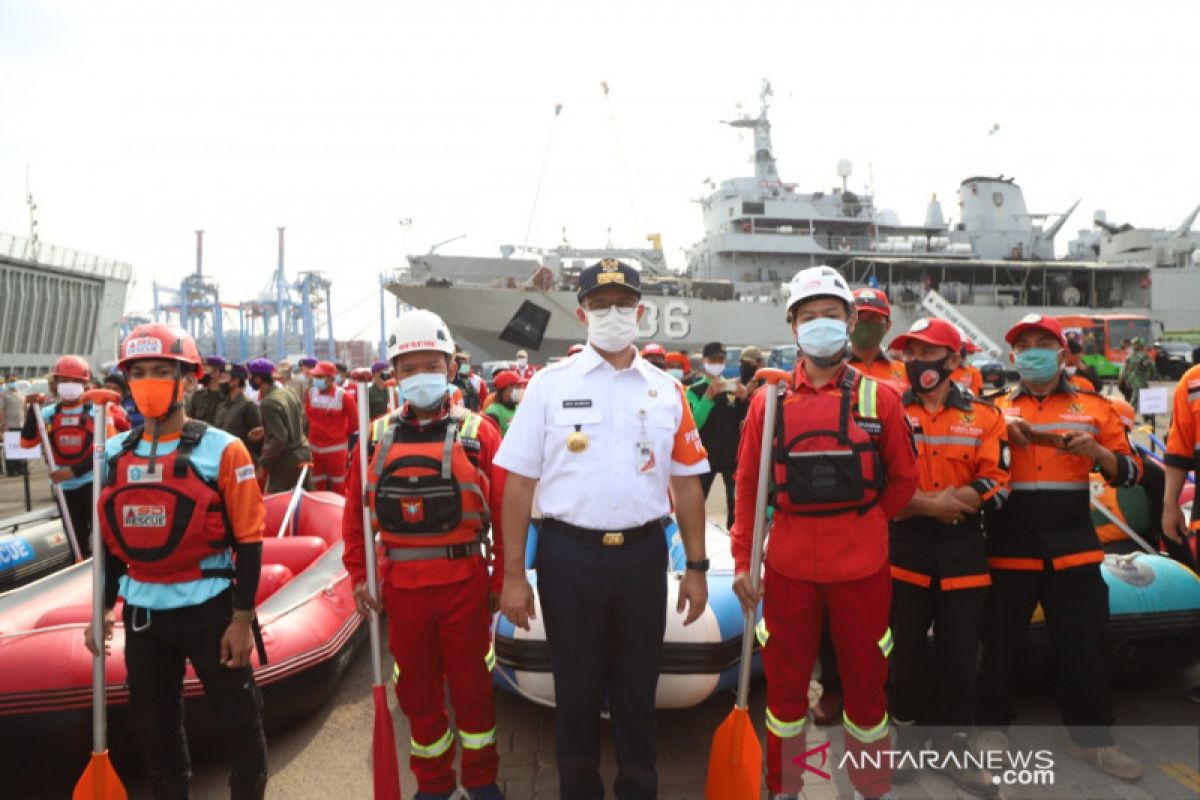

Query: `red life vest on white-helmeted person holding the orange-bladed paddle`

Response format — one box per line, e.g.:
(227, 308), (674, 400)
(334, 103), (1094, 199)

(772, 367), (886, 517)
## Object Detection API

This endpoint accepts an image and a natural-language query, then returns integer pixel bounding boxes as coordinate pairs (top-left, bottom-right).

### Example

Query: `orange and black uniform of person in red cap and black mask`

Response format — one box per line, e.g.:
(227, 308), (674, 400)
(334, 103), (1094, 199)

(890, 386), (1009, 729)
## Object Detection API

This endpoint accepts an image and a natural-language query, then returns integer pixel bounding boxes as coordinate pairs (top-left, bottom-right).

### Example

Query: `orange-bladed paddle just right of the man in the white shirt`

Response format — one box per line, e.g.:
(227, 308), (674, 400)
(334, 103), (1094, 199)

(704, 369), (788, 800)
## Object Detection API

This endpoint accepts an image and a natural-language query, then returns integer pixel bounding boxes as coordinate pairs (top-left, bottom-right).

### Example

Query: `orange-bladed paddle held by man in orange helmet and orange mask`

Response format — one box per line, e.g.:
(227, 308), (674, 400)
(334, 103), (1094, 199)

(74, 389), (128, 800)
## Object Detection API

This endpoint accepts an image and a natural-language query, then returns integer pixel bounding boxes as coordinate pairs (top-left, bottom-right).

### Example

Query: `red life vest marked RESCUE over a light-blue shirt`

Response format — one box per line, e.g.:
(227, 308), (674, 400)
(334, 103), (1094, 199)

(100, 420), (234, 583)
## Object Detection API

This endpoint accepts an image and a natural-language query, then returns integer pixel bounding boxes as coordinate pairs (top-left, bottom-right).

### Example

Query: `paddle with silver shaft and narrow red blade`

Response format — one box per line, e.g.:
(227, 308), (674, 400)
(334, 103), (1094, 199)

(350, 369), (400, 800)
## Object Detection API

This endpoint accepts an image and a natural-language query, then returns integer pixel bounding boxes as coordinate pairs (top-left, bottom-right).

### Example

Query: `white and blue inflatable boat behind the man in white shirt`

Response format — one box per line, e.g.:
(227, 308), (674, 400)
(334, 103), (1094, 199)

(492, 519), (762, 709)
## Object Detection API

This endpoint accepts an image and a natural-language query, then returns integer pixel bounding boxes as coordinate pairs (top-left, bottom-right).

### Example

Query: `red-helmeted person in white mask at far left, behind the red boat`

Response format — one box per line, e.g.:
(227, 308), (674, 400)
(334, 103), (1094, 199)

(20, 355), (124, 558)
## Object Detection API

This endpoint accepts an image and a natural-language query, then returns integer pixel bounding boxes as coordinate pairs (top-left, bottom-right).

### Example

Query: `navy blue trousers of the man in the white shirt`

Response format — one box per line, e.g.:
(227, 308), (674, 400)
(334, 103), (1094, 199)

(536, 521), (667, 800)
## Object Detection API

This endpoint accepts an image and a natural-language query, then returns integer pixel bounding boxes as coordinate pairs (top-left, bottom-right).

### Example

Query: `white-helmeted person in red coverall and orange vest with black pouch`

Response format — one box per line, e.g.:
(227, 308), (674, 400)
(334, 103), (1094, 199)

(342, 309), (504, 800)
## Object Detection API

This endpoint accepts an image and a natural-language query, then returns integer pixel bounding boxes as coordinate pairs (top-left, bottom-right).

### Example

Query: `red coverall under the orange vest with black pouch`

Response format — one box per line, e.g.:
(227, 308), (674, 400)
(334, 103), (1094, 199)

(342, 405), (505, 794)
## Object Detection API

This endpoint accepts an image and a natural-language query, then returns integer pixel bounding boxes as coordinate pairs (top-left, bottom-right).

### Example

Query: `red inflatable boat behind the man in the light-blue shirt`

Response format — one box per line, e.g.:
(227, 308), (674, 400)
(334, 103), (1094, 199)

(0, 492), (366, 756)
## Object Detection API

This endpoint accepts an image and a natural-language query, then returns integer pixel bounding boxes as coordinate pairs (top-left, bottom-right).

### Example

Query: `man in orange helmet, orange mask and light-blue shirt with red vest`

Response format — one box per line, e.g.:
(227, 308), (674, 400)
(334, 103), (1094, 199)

(84, 324), (268, 800)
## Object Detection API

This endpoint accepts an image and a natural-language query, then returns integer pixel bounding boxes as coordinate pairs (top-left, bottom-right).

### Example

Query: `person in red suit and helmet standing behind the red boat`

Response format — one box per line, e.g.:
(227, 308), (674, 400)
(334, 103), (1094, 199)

(304, 361), (359, 494)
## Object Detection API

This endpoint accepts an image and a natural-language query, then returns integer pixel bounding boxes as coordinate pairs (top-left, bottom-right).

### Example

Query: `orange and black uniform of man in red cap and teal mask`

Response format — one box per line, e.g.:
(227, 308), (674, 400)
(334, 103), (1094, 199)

(977, 373), (1141, 747)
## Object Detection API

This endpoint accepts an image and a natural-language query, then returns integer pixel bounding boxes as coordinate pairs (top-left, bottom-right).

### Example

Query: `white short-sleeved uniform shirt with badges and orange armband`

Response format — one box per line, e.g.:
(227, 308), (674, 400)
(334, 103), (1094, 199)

(496, 347), (709, 530)
